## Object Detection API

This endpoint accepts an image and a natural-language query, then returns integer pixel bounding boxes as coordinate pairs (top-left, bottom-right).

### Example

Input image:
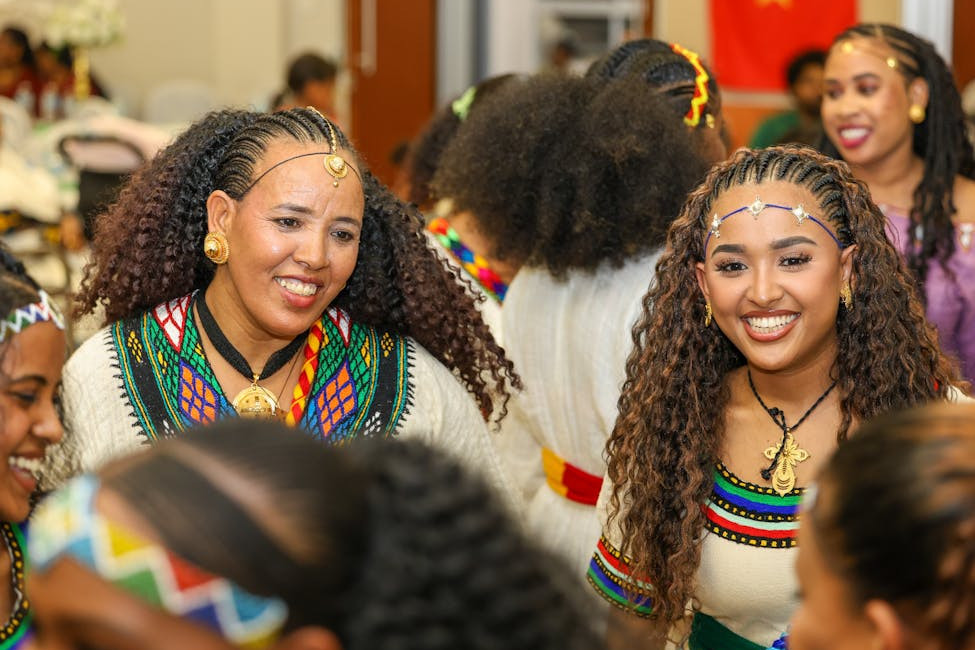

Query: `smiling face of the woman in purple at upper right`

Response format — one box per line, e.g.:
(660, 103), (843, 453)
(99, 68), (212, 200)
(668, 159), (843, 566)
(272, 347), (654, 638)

(822, 37), (927, 166)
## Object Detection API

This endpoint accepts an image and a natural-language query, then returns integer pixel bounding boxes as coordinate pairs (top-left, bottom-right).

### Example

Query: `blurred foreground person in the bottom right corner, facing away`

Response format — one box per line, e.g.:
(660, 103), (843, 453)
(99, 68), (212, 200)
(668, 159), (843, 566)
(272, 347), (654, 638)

(789, 403), (975, 650)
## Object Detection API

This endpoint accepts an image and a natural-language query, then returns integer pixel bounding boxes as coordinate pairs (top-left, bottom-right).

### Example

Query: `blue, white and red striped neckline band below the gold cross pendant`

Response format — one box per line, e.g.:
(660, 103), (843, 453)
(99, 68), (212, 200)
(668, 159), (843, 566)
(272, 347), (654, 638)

(704, 463), (803, 548)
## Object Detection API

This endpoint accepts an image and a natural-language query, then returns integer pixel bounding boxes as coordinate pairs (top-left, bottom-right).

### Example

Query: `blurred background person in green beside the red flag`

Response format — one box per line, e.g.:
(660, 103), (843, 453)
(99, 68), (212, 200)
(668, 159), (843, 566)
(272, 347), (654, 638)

(748, 50), (826, 149)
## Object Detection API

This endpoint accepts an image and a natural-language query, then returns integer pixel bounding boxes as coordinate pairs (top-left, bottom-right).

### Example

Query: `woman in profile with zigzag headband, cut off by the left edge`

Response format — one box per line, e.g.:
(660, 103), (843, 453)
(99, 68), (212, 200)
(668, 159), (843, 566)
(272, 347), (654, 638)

(0, 249), (67, 650)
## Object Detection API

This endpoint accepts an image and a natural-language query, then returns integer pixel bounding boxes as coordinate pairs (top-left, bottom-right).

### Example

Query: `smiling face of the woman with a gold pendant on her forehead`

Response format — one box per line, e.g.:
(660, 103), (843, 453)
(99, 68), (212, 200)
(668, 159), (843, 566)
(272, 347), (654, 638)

(207, 139), (364, 340)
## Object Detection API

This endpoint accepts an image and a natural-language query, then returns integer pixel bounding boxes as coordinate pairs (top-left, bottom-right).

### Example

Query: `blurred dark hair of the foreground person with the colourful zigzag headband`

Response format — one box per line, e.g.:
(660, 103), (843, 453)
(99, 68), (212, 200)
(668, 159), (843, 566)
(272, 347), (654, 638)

(101, 420), (600, 650)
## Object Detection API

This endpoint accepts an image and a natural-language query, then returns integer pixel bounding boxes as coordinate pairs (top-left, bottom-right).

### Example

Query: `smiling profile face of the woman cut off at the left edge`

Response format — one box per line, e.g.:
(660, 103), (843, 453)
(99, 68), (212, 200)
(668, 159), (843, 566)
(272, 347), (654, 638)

(0, 322), (66, 521)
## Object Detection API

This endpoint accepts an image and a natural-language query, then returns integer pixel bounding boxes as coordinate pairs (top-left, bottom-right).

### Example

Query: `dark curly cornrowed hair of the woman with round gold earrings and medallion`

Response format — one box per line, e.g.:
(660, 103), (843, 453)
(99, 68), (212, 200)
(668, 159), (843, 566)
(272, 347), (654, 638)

(76, 108), (520, 416)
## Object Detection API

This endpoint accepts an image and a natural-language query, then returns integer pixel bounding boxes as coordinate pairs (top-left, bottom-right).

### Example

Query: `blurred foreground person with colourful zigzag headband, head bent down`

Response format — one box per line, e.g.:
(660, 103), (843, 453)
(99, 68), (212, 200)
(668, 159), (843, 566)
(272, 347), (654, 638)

(29, 420), (599, 650)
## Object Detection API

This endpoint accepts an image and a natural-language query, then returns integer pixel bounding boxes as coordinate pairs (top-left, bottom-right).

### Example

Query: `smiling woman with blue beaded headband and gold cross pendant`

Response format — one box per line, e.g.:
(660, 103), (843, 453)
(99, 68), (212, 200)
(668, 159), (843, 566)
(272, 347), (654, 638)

(589, 147), (966, 649)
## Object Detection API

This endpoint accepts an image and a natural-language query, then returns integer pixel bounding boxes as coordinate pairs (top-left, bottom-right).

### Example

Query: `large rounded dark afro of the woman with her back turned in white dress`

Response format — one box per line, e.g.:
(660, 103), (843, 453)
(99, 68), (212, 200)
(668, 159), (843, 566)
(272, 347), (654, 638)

(434, 75), (711, 277)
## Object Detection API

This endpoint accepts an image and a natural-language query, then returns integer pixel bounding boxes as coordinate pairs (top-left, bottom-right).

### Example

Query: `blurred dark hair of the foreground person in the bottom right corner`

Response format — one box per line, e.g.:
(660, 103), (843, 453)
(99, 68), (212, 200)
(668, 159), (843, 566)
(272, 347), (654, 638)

(809, 404), (975, 650)
